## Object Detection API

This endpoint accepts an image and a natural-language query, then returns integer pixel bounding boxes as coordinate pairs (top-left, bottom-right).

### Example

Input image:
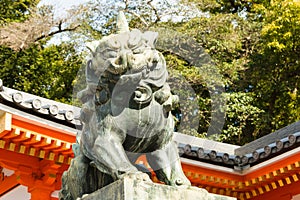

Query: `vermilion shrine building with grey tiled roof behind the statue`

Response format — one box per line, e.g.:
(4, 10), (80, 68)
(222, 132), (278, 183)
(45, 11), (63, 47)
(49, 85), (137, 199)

(0, 80), (300, 200)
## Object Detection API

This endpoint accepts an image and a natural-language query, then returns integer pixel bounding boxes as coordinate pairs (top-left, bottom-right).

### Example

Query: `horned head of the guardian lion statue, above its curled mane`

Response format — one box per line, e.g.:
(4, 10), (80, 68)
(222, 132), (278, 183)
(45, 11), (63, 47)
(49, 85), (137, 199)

(88, 11), (163, 76)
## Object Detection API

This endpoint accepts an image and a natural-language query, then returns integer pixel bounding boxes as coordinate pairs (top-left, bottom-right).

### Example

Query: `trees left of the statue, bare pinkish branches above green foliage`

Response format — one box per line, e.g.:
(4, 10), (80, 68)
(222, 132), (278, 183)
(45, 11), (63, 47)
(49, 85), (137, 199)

(0, 1), (82, 103)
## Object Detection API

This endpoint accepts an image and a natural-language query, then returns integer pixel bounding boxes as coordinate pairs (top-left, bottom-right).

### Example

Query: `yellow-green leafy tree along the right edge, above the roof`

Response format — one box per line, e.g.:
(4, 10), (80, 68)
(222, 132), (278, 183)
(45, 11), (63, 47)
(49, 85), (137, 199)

(245, 0), (300, 135)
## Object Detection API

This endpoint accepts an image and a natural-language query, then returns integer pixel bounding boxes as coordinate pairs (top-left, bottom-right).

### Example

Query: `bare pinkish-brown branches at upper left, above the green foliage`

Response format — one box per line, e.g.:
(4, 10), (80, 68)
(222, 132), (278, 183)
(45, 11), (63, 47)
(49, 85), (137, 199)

(0, 4), (84, 51)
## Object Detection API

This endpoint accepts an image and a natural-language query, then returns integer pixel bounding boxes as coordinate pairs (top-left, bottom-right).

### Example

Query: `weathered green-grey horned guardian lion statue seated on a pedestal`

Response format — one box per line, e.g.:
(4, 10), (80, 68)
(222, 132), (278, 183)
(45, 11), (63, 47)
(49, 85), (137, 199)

(59, 12), (190, 200)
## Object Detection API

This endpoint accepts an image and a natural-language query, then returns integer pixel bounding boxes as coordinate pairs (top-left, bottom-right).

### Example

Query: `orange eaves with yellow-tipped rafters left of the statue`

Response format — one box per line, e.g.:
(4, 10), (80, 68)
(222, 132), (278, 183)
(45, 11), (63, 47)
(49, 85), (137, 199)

(0, 112), (75, 164)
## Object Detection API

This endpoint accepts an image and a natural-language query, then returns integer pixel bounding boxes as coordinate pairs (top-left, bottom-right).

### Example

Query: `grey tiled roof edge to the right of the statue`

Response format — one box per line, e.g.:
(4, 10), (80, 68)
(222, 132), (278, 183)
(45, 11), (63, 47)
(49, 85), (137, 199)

(177, 121), (300, 170)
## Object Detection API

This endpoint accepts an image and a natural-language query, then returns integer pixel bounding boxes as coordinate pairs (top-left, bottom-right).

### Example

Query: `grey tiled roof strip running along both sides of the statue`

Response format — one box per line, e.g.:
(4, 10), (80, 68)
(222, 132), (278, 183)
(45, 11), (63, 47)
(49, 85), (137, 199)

(0, 79), (300, 170)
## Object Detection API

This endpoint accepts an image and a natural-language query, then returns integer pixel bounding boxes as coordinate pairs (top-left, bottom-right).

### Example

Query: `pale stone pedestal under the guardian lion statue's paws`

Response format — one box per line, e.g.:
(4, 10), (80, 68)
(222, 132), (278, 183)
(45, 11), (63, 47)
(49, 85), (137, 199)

(80, 178), (236, 200)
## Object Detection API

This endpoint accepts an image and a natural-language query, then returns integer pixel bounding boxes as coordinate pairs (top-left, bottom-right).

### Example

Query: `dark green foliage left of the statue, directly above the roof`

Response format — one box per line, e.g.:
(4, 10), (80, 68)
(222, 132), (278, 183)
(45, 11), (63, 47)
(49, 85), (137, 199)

(0, 44), (82, 102)
